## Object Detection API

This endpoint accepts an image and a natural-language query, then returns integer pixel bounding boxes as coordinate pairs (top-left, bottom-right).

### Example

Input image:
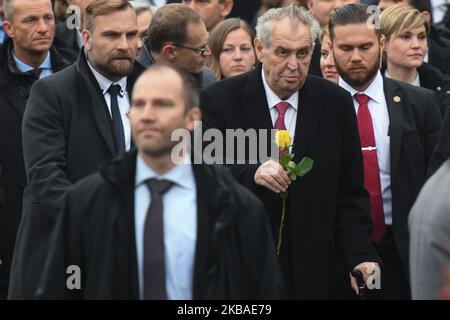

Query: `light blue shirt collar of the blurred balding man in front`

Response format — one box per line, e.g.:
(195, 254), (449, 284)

(136, 153), (195, 190)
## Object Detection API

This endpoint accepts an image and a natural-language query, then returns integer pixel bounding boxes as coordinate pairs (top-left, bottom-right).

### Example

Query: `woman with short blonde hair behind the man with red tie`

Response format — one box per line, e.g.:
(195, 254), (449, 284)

(381, 4), (450, 114)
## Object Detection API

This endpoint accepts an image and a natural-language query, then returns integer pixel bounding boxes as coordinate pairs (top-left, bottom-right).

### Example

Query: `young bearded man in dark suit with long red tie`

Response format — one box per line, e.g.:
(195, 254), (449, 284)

(329, 4), (442, 299)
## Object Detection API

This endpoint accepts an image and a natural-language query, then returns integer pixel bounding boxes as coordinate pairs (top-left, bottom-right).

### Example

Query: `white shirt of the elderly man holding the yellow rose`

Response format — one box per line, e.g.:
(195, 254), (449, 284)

(261, 70), (298, 151)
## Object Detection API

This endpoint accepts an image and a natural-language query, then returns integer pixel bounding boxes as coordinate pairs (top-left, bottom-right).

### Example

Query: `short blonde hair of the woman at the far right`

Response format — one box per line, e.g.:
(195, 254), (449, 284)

(380, 4), (429, 41)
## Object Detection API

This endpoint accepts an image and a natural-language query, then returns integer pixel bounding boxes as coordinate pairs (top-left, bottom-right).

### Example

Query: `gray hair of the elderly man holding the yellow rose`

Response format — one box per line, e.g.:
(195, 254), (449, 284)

(256, 4), (320, 48)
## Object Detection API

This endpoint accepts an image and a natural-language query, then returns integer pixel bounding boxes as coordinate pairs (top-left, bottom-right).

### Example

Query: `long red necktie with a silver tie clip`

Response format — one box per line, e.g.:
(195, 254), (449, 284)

(355, 94), (385, 243)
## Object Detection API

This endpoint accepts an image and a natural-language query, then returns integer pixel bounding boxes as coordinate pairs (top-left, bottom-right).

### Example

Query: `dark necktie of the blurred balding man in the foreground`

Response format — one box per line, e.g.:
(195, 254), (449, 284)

(144, 179), (173, 300)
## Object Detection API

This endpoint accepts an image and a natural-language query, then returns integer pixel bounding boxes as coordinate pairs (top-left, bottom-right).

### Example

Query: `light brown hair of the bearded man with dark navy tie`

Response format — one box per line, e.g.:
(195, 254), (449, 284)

(84, 0), (134, 32)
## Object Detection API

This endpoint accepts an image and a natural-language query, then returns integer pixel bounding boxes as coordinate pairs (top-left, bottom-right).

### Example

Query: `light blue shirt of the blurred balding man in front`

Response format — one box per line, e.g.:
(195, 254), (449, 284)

(134, 155), (197, 300)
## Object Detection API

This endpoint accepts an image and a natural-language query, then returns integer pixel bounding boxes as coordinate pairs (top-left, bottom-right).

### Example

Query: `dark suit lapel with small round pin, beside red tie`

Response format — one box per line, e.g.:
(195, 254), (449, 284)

(383, 78), (404, 185)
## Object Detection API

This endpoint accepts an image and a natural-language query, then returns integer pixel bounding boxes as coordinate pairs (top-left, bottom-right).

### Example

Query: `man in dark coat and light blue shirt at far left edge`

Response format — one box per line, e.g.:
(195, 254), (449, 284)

(0, 0), (69, 299)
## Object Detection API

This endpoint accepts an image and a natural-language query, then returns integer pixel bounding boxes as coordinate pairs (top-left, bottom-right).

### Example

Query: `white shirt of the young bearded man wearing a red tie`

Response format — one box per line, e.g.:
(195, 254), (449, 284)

(339, 71), (392, 225)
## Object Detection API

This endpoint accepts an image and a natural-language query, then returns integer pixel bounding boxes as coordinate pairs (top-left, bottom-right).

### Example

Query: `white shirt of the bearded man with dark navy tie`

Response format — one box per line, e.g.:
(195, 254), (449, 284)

(88, 62), (131, 151)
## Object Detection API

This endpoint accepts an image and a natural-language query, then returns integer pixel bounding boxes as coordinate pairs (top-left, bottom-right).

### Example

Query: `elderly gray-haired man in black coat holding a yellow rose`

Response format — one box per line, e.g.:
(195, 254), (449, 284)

(201, 5), (379, 299)
